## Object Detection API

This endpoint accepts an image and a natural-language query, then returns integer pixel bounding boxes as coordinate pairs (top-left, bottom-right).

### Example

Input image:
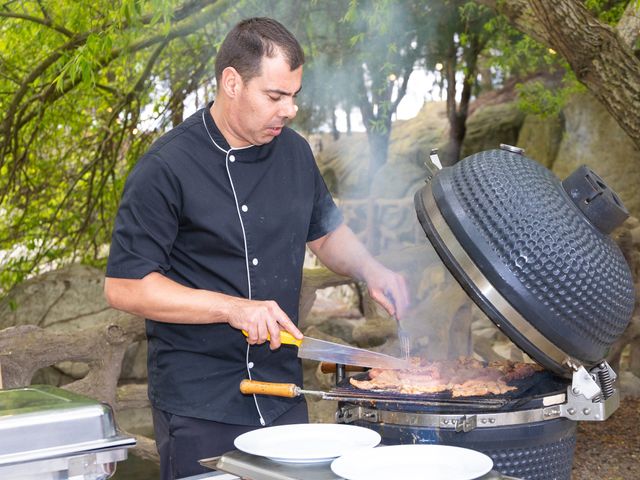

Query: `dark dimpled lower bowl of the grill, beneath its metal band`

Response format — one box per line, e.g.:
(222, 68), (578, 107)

(352, 412), (577, 480)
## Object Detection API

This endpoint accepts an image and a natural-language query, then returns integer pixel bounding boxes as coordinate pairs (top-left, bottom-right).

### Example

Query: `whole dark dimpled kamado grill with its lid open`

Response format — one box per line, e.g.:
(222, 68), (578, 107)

(240, 145), (634, 480)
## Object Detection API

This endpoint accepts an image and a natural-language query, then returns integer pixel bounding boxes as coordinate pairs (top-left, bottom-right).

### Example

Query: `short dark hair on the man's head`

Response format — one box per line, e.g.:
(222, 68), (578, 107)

(216, 17), (304, 82)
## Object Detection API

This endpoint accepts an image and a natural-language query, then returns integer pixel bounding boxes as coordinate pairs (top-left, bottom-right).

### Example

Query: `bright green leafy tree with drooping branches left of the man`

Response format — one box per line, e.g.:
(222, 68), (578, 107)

(0, 0), (231, 288)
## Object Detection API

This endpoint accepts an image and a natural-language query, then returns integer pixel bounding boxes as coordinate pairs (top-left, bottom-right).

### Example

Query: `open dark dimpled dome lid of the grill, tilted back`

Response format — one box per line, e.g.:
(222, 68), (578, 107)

(414, 149), (634, 376)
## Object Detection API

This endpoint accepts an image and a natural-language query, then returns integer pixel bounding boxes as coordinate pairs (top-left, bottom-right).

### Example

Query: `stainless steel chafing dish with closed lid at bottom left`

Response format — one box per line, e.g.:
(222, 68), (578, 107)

(0, 385), (136, 480)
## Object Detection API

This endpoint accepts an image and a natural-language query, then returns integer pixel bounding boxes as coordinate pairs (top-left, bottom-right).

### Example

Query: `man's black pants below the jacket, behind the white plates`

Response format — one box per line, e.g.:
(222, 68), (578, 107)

(153, 402), (309, 480)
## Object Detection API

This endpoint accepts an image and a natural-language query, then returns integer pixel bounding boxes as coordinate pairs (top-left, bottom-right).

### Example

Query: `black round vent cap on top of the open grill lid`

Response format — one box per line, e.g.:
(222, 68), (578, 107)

(562, 165), (629, 235)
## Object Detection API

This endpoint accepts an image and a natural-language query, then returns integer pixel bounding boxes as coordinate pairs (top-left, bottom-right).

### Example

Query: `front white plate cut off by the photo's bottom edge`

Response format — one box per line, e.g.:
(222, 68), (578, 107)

(331, 445), (493, 480)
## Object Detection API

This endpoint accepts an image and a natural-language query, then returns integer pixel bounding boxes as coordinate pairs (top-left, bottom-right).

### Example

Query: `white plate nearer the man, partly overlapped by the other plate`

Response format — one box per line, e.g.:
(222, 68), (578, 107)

(234, 423), (380, 463)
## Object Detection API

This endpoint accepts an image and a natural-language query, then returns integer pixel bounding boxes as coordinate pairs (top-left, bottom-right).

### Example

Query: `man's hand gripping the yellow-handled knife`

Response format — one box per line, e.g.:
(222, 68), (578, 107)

(227, 298), (303, 350)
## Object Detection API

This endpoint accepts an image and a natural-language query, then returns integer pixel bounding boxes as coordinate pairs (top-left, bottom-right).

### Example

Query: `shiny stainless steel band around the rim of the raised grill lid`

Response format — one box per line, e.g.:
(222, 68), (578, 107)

(422, 184), (580, 366)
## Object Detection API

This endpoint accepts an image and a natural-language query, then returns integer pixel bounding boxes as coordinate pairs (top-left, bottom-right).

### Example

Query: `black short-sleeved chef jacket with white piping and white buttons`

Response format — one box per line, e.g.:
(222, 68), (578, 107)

(107, 105), (342, 425)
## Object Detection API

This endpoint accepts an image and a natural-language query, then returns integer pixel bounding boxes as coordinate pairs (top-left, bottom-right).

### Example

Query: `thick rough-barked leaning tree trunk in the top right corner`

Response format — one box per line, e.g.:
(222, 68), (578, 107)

(478, 0), (640, 148)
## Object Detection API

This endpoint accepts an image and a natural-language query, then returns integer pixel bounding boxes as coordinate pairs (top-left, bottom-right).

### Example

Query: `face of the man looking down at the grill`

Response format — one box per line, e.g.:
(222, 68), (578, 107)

(230, 54), (302, 146)
